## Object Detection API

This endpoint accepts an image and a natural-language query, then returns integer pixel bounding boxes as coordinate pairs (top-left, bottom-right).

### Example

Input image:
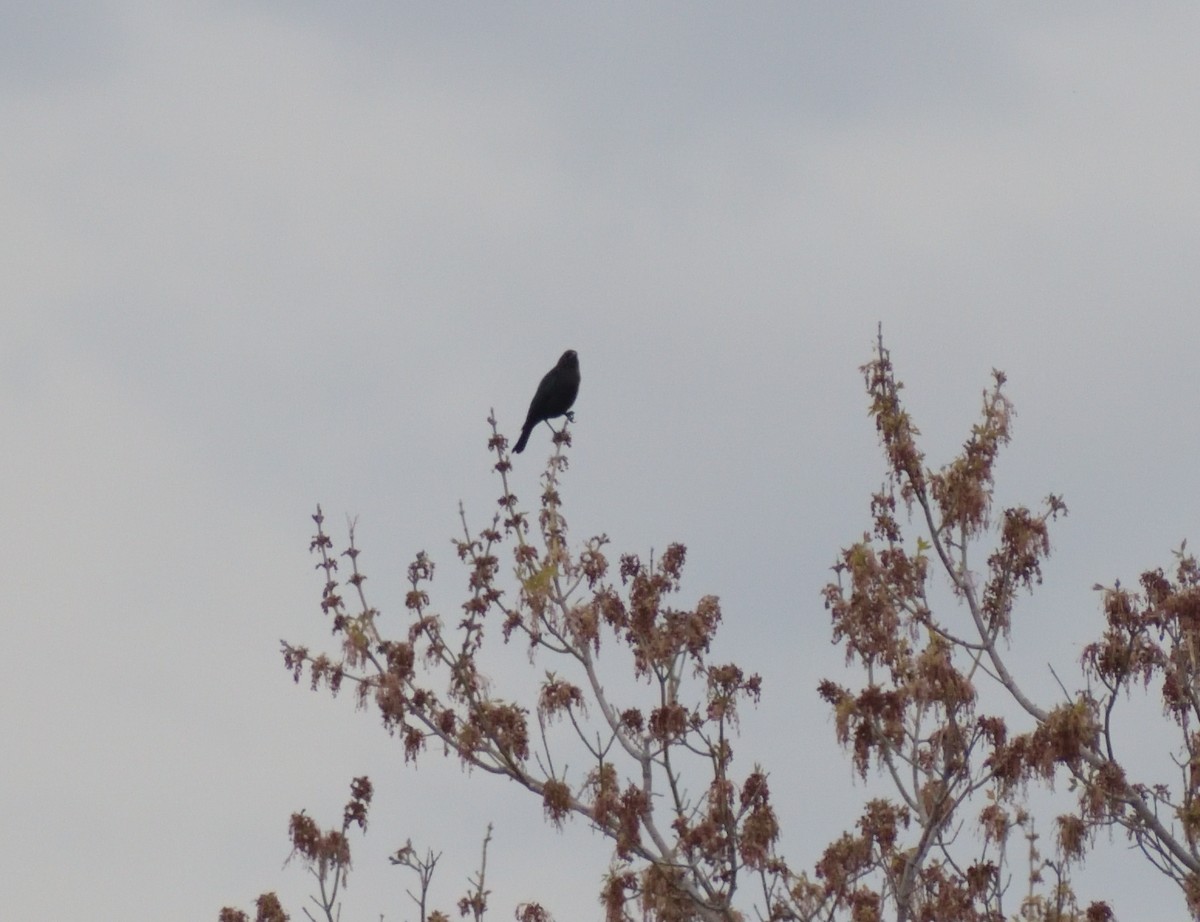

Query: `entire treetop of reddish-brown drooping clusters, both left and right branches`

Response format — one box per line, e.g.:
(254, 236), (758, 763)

(226, 337), (1200, 922)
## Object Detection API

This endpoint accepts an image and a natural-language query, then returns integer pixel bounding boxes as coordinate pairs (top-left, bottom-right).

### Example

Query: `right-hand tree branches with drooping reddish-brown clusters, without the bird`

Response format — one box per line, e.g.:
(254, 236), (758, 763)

(821, 340), (1200, 920)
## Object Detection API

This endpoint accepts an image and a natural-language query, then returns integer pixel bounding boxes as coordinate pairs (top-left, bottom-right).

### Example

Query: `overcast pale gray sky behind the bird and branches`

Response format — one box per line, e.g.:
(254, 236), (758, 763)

(0, 0), (1200, 922)
